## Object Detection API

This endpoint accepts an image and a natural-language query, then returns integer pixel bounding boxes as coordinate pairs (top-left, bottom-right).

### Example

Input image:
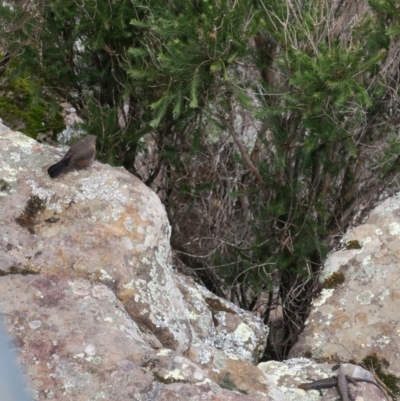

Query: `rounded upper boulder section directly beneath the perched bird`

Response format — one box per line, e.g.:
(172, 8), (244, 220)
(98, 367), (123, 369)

(0, 123), (191, 351)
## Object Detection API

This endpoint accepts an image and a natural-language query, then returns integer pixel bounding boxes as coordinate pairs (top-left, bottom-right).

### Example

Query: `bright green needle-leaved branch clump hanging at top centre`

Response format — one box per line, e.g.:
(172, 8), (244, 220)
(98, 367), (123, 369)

(128, 0), (260, 127)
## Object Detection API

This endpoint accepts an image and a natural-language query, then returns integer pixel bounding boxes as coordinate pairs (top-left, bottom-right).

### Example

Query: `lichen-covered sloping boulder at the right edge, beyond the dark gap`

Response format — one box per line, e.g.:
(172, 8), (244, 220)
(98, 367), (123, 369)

(290, 196), (400, 375)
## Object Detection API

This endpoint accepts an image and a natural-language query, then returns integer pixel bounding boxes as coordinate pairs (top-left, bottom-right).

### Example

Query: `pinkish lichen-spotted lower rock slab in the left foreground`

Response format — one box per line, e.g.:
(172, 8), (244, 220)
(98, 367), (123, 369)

(0, 275), (262, 400)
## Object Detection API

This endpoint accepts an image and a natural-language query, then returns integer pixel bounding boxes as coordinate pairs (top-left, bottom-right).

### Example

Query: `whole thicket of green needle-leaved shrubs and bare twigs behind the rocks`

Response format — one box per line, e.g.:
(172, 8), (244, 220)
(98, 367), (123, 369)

(0, 0), (400, 358)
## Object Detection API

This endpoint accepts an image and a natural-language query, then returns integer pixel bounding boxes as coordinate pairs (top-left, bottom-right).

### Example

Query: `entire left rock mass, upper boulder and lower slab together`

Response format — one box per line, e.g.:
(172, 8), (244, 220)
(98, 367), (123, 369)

(0, 125), (270, 401)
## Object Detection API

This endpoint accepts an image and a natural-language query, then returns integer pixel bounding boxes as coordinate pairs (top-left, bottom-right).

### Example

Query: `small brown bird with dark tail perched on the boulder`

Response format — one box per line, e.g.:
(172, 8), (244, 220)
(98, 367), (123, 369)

(47, 135), (96, 178)
